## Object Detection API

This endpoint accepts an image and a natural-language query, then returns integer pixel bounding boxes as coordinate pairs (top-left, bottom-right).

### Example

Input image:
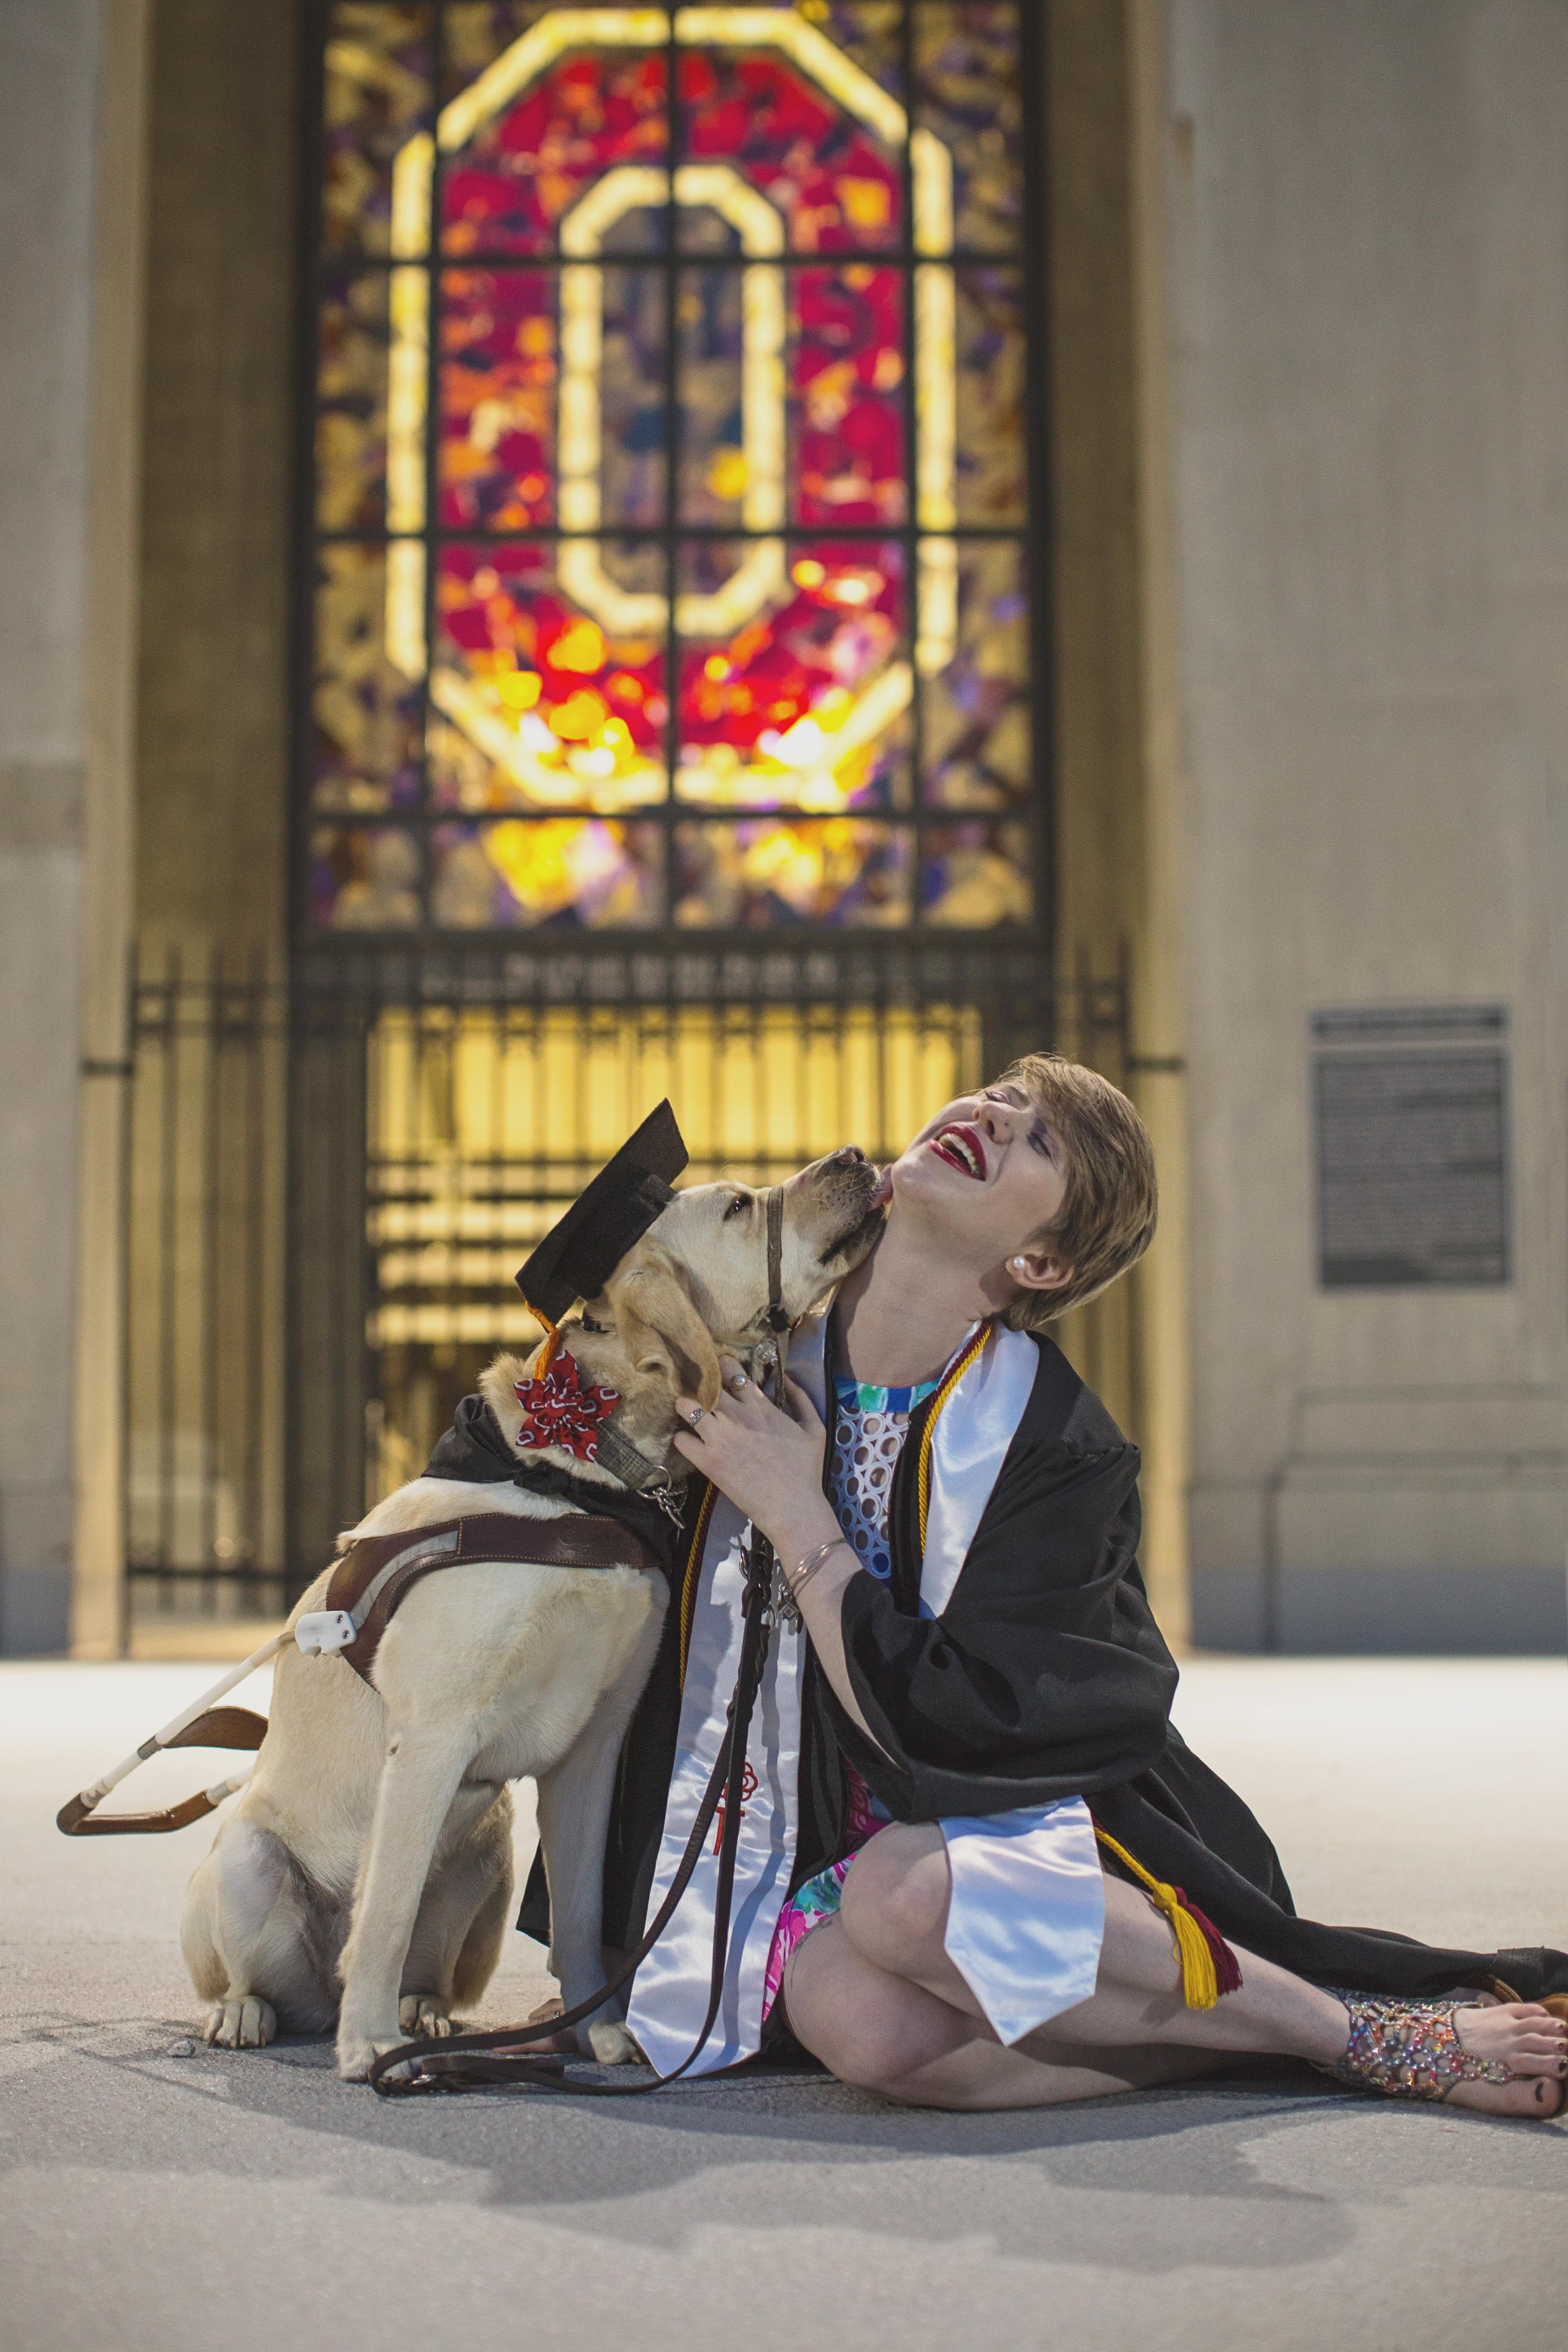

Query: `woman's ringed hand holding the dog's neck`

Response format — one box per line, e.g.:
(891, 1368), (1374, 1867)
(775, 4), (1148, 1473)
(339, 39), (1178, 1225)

(675, 1355), (839, 1566)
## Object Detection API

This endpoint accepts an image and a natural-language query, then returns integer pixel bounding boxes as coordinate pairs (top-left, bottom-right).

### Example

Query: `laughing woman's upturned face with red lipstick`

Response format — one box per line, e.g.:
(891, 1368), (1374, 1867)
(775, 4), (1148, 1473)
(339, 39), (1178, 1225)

(889, 1082), (1072, 1289)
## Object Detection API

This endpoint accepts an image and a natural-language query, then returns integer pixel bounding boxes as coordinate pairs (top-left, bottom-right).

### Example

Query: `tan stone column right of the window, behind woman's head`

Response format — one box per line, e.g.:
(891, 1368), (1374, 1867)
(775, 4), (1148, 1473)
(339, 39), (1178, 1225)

(1044, 0), (1189, 1644)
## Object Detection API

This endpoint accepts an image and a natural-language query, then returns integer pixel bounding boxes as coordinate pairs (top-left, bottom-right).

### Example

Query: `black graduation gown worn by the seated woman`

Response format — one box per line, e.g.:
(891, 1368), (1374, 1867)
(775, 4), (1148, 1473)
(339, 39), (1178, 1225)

(517, 1341), (1568, 1999)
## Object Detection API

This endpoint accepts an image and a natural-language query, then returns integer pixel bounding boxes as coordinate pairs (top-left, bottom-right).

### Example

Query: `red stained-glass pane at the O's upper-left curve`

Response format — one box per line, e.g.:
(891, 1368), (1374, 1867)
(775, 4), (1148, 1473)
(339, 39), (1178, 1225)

(442, 49), (668, 254)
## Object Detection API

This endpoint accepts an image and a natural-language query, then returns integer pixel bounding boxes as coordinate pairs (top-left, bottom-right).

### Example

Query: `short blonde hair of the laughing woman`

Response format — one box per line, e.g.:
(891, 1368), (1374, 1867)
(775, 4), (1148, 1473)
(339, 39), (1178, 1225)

(997, 1053), (1159, 1331)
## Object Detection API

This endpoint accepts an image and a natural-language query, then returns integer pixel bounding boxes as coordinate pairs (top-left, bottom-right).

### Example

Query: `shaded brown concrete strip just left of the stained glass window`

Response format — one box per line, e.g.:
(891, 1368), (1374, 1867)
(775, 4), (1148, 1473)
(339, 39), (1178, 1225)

(137, 0), (301, 976)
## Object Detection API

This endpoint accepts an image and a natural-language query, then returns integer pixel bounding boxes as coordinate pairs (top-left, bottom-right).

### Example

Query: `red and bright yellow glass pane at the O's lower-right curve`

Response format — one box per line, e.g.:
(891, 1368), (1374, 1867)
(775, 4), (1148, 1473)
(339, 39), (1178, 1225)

(675, 541), (907, 809)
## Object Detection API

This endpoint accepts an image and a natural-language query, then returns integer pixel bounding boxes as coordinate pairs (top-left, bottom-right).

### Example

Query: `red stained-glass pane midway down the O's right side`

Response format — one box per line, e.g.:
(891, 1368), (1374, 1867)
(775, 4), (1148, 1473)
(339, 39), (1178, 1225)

(790, 263), (907, 527)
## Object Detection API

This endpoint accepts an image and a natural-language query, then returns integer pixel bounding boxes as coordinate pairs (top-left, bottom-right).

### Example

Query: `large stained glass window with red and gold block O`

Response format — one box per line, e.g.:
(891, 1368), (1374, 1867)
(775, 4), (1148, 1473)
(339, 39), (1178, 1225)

(303, 0), (1039, 934)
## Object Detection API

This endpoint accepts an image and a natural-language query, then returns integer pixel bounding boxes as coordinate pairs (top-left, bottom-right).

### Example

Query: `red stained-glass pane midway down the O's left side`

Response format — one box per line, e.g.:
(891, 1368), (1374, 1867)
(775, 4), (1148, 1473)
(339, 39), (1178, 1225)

(440, 270), (557, 531)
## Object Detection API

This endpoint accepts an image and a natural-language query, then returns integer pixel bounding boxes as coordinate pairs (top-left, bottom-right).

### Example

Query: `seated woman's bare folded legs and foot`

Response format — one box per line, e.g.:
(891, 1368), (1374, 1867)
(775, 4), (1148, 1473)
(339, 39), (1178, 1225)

(785, 1825), (1568, 2115)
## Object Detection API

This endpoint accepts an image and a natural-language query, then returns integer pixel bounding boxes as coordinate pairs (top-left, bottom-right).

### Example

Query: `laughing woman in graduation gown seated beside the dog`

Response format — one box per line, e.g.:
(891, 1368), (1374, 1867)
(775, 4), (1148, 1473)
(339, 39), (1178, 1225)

(550, 1056), (1568, 2117)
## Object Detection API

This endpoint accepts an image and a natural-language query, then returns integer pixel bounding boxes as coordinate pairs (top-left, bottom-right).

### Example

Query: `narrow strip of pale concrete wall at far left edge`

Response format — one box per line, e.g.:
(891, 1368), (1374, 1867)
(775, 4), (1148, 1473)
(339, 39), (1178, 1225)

(0, 0), (99, 1651)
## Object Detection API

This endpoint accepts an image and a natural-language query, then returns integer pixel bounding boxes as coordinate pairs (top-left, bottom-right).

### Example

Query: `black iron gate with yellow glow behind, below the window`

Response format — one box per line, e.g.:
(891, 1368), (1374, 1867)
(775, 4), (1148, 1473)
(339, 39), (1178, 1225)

(127, 941), (1123, 1618)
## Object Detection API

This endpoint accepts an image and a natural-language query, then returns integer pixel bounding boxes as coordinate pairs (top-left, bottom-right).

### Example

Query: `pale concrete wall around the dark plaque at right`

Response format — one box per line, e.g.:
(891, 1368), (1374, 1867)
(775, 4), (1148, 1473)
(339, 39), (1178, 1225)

(1171, 0), (1568, 1649)
